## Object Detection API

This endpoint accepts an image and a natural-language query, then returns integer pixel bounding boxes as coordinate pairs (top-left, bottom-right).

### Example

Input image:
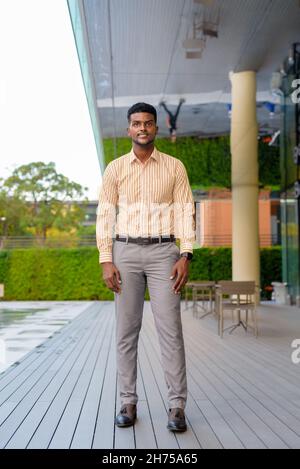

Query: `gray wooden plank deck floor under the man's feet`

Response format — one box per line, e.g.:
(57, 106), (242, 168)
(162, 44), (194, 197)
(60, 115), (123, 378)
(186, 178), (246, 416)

(0, 302), (300, 449)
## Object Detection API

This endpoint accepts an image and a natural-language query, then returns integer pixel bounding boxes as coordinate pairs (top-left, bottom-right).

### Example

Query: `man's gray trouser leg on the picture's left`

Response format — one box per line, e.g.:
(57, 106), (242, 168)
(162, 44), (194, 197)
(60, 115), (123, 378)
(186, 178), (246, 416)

(113, 241), (146, 406)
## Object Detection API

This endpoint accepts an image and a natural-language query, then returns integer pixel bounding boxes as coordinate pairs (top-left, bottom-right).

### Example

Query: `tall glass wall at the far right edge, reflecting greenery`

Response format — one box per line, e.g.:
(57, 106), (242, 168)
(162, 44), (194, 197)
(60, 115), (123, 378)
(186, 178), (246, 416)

(281, 45), (300, 306)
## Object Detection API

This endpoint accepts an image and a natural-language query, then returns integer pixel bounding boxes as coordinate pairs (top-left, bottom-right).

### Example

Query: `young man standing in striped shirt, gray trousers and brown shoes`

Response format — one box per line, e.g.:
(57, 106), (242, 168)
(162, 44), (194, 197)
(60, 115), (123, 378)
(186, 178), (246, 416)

(97, 103), (195, 431)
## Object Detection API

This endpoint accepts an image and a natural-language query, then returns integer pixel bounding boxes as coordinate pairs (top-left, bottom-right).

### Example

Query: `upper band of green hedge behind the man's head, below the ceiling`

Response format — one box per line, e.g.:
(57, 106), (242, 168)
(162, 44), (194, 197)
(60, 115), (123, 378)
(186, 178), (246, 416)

(103, 137), (280, 189)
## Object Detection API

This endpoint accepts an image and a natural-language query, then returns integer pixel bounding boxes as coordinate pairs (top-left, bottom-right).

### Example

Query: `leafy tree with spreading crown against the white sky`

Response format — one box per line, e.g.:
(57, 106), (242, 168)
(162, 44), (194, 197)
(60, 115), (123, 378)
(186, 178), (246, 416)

(3, 162), (87, 239)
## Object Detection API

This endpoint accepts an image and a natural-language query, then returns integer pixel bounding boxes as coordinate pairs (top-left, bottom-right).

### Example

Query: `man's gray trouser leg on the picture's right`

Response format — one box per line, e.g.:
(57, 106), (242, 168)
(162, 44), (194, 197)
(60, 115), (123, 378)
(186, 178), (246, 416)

(145, 243), (187, 409)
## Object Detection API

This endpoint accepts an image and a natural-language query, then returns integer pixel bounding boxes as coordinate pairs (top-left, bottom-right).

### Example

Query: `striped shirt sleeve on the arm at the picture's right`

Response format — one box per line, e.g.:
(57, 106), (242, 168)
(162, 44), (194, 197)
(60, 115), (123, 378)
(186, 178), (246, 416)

(173, 160), (196, 253)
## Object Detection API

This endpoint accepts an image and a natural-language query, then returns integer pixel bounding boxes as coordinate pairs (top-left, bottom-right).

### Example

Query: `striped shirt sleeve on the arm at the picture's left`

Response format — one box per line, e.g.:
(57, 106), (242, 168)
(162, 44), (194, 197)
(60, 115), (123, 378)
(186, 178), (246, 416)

(96, 162), (118, 264)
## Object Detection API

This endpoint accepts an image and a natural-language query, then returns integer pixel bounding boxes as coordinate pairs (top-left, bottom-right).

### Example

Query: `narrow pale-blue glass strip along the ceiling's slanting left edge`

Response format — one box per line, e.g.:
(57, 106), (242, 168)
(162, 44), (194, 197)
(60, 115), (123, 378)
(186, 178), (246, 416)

(68, 0), (105, 173)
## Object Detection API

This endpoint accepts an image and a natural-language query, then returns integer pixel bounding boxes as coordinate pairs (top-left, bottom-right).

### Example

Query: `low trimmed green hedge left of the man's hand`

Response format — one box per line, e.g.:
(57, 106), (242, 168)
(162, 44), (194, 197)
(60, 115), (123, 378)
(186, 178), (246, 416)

(0, 248), (113, 300)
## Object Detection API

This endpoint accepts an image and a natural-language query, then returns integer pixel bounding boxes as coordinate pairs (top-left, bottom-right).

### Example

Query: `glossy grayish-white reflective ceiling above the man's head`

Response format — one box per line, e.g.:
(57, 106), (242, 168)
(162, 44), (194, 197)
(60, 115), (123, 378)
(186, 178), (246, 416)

(83, 0), (300, 136)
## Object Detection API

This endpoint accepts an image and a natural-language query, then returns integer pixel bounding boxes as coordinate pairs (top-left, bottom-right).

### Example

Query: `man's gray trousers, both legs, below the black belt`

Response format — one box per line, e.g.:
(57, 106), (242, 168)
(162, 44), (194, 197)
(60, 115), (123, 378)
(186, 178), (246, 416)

(113, 241), (187, 409)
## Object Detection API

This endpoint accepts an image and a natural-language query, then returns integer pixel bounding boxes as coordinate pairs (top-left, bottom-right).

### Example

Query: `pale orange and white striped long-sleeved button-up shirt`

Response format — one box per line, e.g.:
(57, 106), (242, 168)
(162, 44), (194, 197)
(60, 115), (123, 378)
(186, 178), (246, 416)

(96, 148), (195, 263)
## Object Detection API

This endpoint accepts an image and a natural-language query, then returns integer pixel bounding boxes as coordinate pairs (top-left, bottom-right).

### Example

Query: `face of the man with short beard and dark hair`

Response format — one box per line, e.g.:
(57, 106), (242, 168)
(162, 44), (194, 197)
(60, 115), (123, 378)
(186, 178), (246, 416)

(127, 112), (158, 146)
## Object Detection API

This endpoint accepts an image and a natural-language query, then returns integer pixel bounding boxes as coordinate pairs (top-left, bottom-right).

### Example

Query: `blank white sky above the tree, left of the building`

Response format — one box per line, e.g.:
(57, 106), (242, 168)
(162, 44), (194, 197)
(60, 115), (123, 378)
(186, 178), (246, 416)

(0, 0), (101, 200)
